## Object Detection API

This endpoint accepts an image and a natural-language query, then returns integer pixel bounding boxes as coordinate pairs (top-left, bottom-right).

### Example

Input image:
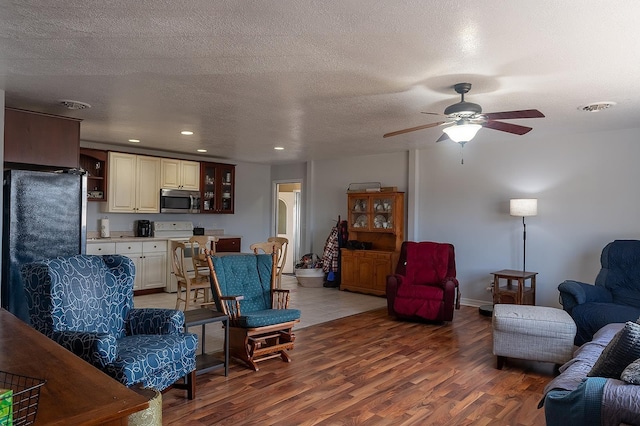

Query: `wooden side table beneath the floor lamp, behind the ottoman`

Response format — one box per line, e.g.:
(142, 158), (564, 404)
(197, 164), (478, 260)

(491, 269), (538, 305)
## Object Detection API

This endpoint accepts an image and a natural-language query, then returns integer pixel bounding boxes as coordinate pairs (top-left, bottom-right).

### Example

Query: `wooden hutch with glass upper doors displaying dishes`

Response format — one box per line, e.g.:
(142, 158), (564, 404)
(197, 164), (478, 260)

(340, 188), (404, 296)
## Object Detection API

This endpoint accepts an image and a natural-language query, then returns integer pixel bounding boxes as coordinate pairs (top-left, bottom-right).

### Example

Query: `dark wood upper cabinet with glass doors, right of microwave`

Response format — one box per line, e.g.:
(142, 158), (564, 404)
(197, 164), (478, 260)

(200, 163), (236, 214)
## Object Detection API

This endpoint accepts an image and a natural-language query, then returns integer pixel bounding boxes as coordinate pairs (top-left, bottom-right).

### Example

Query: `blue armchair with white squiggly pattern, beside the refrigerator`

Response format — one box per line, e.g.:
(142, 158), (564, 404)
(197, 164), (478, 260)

(21, 255), (198, 399)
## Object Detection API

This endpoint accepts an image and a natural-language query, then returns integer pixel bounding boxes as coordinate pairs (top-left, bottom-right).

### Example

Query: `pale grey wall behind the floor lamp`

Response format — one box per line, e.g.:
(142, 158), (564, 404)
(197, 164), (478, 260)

(417, 126), (640, 306)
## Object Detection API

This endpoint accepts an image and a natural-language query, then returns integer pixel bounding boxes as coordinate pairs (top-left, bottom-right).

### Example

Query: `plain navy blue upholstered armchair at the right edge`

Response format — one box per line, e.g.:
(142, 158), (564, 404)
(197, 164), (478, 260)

(558, 240), (640, 346)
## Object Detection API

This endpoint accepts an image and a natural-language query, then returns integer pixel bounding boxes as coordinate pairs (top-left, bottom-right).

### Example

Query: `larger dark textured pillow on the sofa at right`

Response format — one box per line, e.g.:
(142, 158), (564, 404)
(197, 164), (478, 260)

(587, 321), (640, 379)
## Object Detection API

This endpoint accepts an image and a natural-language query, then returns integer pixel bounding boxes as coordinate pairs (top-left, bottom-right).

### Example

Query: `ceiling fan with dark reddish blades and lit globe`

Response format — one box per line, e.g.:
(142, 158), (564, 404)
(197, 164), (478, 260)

(383, 83), (544, 145)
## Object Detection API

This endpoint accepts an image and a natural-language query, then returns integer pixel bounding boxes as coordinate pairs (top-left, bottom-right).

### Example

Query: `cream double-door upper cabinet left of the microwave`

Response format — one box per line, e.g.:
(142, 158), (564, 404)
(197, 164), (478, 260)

(106, 151), (161, 213)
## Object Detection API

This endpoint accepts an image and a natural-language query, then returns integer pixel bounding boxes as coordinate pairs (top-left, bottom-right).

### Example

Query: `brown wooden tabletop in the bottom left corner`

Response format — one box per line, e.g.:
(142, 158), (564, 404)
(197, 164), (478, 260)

(0, 309), (149, 425)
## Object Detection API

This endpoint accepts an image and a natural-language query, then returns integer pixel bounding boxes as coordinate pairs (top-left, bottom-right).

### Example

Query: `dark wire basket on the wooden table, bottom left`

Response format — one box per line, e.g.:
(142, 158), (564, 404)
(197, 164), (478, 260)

(0, 371), (45, 426)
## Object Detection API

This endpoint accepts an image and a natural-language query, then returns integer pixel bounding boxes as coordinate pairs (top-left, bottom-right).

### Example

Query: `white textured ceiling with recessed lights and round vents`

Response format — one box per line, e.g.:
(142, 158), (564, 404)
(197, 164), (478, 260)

(0, 0), (640, 164)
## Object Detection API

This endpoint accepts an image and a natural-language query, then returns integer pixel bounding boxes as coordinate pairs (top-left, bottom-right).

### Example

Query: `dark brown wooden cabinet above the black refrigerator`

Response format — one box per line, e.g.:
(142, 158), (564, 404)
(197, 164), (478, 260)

(4, 108), (80, 168)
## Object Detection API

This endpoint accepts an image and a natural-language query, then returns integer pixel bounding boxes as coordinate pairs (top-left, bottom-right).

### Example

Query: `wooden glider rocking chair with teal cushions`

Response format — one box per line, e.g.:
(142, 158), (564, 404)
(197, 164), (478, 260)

(207, 254), (300, 371)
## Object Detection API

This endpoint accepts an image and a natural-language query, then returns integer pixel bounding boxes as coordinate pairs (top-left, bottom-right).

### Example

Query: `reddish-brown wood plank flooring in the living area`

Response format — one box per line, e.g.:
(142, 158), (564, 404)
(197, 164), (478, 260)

(162, 306), (553, 426)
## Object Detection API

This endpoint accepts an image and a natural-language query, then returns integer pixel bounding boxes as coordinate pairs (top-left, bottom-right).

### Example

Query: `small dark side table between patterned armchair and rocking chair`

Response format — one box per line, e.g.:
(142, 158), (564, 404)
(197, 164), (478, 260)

(184, 308), (229, 376)
